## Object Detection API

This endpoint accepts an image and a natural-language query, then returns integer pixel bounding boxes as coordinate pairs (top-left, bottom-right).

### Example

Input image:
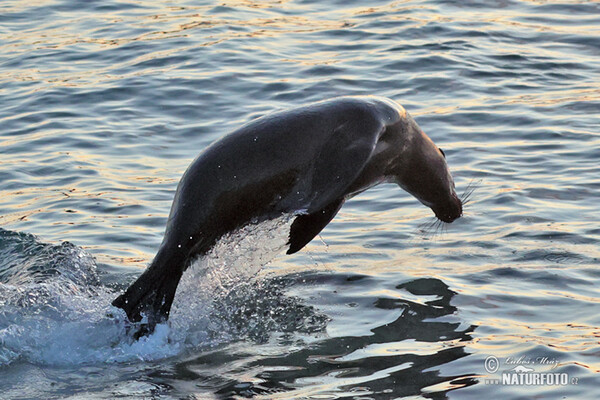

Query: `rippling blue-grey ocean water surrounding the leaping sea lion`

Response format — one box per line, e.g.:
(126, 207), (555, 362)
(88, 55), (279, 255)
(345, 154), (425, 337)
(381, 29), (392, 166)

(0, 0), (600, 399)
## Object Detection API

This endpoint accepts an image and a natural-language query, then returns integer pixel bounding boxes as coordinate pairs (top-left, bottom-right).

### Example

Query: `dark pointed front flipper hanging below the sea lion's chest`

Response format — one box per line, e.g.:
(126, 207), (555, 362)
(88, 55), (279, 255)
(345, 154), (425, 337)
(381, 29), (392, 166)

(287, 199), (344, 254)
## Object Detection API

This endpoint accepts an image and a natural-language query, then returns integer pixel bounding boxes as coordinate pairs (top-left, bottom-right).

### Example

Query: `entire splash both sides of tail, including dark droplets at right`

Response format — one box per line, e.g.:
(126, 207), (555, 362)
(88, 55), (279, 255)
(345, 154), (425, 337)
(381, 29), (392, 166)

(0, 216), (326, 366)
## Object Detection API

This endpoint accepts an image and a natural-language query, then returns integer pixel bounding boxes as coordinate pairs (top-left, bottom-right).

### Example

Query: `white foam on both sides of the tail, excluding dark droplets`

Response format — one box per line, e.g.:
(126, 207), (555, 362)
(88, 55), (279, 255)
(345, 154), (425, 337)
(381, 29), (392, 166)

(0, 217), (292, 366)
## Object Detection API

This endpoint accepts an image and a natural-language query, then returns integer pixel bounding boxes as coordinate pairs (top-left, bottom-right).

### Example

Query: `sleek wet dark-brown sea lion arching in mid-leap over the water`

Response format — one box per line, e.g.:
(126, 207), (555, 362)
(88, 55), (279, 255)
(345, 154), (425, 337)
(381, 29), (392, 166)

(112, 96), (462, 333)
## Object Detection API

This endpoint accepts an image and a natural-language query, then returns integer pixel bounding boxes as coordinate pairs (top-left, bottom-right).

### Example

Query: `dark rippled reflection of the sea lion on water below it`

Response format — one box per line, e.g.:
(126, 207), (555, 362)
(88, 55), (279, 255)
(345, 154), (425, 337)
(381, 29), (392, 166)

(163, 276), (476, 398)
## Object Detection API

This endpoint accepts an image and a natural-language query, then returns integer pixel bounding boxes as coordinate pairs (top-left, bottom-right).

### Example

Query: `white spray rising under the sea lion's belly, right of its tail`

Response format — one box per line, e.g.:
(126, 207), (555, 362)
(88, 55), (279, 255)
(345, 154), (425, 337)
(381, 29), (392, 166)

(170, 215), (293, 345)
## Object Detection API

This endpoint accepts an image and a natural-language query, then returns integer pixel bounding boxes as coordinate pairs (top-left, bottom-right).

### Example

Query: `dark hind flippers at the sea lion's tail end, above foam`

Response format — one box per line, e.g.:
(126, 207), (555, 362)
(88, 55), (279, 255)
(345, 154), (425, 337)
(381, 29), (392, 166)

(112, 252), (183, 339)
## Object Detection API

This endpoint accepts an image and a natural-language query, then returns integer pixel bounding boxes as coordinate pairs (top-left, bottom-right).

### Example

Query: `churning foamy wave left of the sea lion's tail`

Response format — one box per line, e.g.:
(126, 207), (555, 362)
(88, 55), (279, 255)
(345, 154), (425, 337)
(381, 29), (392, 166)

(0, 230), (183, 366)
